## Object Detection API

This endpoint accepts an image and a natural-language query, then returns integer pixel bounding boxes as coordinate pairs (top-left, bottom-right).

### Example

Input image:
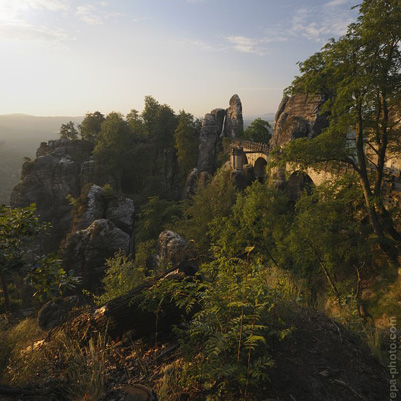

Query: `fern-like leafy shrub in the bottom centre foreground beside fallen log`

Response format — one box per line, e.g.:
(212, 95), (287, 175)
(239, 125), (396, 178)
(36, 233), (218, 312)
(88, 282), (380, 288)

(149, 255), (277, 400)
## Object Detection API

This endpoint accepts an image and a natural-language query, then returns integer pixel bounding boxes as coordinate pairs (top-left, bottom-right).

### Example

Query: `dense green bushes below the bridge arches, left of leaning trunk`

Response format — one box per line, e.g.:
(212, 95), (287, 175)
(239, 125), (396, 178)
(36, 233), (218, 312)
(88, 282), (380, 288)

(278, 175), (374, 297)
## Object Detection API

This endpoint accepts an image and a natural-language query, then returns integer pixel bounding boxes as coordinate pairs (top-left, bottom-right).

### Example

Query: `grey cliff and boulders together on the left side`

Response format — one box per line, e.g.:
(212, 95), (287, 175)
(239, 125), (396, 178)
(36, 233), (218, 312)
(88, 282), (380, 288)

(11, 140), (134, 289)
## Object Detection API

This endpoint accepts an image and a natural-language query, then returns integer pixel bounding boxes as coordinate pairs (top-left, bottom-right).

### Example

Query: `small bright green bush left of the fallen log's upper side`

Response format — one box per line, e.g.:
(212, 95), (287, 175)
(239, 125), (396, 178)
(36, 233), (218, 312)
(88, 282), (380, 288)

(95, 251), (145, 305)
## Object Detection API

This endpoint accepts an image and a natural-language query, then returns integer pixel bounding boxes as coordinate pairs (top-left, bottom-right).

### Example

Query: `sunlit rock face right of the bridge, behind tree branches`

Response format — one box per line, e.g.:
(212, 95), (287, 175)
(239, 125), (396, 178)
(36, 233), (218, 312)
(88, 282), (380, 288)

(271, 93), (328, 146)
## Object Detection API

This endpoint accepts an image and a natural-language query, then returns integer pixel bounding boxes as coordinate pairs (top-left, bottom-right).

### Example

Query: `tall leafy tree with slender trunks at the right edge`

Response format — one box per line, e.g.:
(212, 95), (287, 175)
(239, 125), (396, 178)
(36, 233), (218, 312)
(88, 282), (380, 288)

(283, 0), (401, 249)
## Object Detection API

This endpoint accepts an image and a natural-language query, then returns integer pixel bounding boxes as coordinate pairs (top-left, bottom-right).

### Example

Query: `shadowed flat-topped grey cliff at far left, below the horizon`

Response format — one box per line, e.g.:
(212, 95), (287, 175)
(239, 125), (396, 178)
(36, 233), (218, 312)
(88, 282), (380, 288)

(10, 139), (93, 251)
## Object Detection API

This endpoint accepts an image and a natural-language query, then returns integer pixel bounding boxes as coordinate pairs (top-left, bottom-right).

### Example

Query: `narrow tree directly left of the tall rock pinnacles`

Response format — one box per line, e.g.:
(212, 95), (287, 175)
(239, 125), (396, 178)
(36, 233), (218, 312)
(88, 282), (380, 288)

(174, 111), (199, 180)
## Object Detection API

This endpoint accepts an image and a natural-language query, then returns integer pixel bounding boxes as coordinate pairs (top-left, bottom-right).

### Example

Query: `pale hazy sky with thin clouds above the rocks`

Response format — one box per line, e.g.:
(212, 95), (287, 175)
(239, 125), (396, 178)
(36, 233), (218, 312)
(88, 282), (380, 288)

(0, 0), (358, 117)
